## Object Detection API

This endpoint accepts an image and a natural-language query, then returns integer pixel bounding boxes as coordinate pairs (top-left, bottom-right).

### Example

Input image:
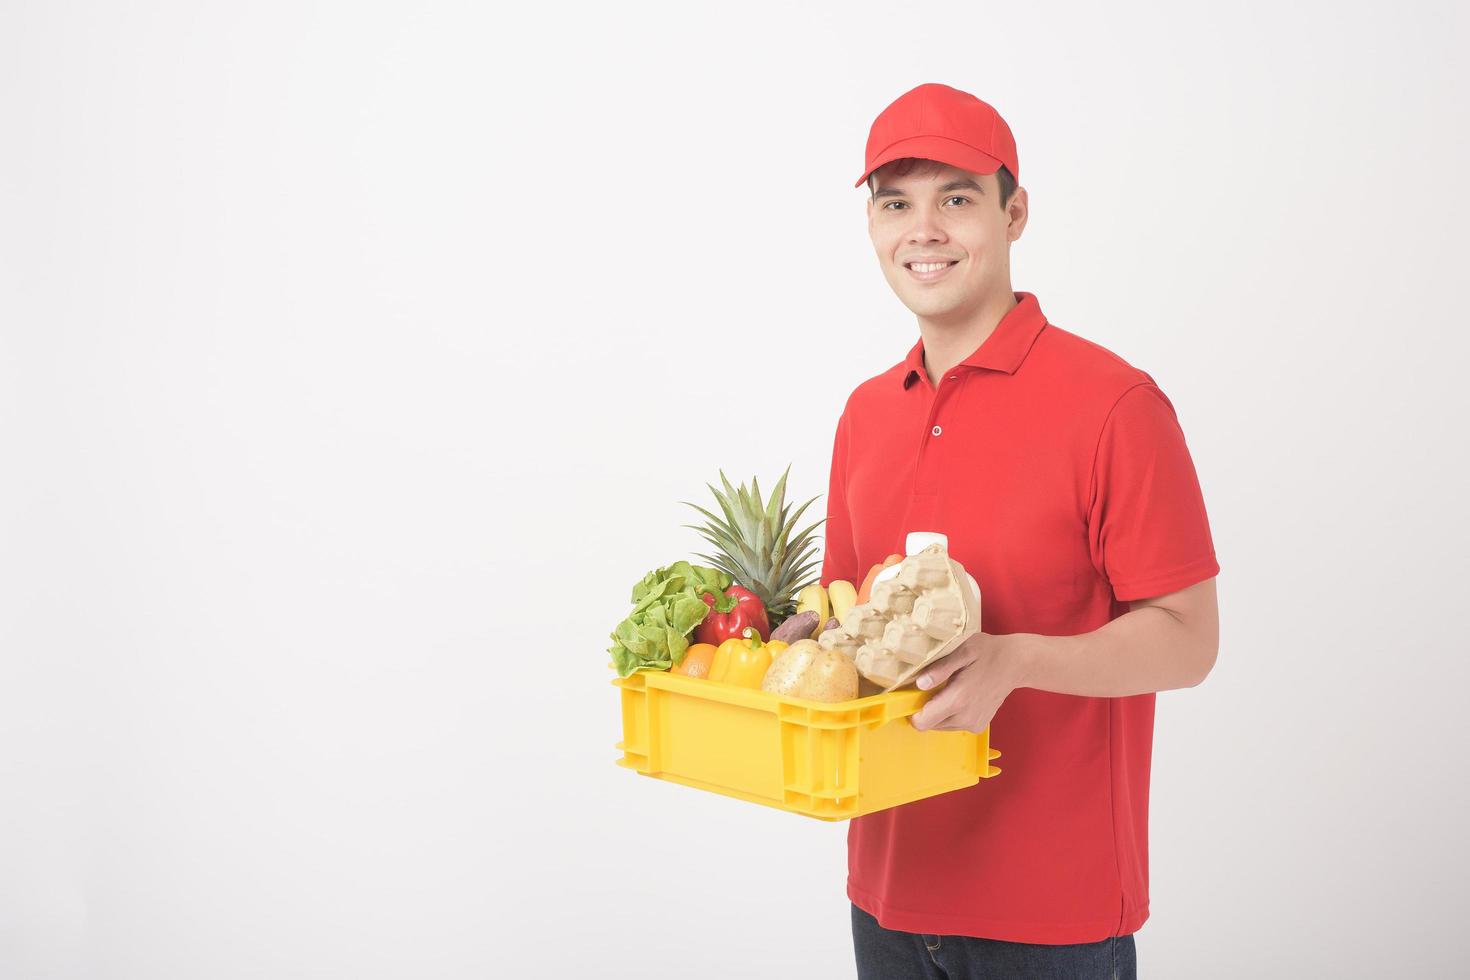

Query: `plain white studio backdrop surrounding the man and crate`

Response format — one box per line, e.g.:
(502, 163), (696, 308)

(0, 3), (1470, 980)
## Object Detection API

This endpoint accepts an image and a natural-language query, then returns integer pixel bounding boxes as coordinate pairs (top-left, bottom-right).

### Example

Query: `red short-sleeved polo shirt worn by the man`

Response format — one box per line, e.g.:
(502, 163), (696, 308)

(822, 292), (1220, 943)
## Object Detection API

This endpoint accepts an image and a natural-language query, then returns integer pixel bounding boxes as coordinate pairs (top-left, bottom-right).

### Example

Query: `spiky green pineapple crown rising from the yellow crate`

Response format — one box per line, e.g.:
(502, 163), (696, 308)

(681, 466), (826, 629)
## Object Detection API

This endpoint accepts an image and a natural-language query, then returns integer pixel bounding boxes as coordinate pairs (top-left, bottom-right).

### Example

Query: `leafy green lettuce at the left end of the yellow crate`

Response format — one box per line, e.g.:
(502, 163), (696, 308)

(607, 561), (731, 677)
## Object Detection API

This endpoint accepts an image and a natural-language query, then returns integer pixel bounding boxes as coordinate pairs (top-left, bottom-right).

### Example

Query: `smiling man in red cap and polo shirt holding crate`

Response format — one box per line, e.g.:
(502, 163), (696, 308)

(822, 84), (1220, 980)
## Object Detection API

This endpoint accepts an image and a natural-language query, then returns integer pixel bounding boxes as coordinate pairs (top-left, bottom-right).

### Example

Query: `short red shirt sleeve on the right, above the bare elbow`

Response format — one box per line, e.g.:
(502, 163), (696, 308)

(1088, 382), (1220, 601)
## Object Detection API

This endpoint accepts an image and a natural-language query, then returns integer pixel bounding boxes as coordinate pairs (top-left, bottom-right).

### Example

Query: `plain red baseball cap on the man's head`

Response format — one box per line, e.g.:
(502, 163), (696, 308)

(853, 82), (1020, 187)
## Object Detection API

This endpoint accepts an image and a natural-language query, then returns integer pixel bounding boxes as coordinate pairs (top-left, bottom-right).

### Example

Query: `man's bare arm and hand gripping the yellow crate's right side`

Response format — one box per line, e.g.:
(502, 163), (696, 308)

(913, 577), (1220, 732)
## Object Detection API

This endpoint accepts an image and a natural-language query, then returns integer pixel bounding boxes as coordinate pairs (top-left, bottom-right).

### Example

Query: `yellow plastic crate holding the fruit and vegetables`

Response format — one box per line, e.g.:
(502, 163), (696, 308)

(613, 670), (1001, 820)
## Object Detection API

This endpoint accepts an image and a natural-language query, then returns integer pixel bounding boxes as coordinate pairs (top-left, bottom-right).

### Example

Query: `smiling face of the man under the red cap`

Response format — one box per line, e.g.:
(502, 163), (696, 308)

(867, 165), (1026, 320)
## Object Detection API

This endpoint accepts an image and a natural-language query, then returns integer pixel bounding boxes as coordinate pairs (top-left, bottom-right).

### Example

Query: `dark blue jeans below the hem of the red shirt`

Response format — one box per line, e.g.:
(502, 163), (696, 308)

(853, 905), (1138, 980)
